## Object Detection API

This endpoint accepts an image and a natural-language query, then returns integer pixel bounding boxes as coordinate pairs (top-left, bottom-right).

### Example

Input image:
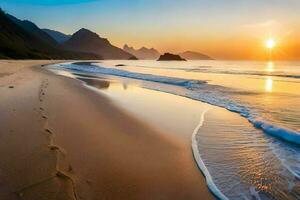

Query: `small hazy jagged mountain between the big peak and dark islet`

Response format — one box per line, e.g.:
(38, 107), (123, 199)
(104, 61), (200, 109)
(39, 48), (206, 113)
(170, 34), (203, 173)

(123, 44), (160, 60)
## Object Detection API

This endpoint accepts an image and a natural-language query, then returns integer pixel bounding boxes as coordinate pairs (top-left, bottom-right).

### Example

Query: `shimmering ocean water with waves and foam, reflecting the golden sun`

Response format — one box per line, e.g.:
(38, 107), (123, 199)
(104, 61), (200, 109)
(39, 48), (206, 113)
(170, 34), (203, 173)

(50, 60), (300, 199)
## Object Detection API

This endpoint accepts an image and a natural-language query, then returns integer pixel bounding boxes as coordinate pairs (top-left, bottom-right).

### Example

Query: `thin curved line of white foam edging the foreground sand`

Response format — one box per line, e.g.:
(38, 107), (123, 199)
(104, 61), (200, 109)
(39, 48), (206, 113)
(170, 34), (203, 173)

(192, 109), (229, 200)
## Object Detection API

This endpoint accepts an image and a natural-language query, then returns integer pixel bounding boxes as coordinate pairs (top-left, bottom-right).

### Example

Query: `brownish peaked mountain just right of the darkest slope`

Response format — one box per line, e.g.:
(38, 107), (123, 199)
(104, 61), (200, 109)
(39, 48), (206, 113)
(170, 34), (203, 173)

(63, 28), (133, 60)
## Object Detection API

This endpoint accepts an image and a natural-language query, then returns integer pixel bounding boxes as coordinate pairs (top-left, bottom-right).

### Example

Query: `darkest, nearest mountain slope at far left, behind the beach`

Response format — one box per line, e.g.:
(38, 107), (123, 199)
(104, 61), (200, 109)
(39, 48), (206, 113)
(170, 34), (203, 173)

(0, 8), (100, 59)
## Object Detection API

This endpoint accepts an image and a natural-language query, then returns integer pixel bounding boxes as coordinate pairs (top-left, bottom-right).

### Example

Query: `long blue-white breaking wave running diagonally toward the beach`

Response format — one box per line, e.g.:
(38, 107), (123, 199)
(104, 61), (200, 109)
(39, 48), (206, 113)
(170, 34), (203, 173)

(61, 63), (300, 145)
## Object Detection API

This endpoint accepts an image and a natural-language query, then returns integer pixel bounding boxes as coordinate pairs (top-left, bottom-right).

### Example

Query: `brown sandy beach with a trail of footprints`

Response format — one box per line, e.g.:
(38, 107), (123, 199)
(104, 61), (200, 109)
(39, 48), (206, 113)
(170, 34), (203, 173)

(0, 60), (214, 200)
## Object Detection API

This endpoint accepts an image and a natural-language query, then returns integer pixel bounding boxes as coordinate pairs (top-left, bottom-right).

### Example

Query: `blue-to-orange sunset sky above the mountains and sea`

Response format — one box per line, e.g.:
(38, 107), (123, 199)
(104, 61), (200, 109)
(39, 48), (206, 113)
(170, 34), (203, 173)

(0, 0), (300, 60)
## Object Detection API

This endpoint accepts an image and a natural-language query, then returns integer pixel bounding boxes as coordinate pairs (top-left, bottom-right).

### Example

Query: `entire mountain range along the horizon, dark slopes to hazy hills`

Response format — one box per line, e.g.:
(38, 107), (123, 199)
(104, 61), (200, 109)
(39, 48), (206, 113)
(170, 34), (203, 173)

(0, 8), (212, 60)
